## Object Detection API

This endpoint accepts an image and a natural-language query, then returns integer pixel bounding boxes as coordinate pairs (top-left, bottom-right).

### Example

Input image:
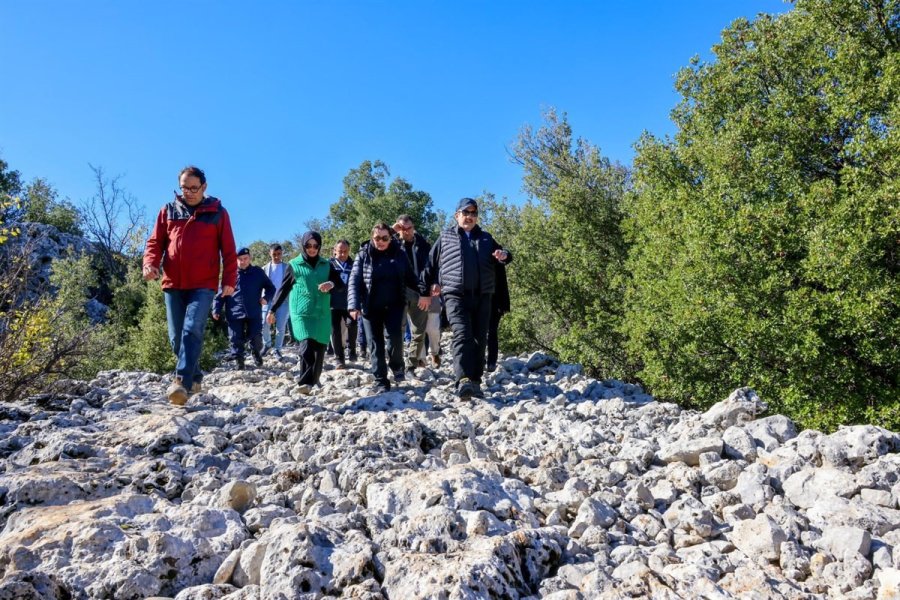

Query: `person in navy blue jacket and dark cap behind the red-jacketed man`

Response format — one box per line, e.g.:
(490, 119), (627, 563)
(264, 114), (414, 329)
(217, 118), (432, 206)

(213, 248), (275, 369)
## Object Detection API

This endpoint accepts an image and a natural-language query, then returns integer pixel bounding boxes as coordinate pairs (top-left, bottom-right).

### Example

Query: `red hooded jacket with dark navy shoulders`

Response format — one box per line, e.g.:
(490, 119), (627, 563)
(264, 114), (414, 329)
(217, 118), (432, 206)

(144, 197), (237, 290)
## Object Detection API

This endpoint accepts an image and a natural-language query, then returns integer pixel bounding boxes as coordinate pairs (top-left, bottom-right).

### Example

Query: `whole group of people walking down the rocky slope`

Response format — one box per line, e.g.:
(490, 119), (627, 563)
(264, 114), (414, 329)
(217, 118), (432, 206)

(143, 166), (512, 405)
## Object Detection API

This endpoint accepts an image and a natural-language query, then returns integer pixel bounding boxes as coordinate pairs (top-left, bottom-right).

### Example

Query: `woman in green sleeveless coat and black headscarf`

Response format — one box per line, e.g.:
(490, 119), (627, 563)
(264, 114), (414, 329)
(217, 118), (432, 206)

(269, 231), (345, 391)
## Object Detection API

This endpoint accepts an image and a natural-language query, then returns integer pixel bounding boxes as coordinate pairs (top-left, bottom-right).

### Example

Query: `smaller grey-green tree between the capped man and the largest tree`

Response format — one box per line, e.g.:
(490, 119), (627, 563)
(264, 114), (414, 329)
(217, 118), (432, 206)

(500, 110), (633, 377)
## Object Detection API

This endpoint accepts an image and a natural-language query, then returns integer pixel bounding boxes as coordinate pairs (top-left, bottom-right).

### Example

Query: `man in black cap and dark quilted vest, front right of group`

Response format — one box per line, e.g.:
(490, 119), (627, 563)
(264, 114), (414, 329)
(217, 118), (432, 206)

(419, 198), (512, 398)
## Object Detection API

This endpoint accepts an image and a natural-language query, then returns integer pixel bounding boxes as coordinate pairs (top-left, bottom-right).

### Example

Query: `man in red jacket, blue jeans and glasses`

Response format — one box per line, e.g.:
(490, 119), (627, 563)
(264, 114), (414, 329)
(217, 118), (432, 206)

(143, 166), (237, 406)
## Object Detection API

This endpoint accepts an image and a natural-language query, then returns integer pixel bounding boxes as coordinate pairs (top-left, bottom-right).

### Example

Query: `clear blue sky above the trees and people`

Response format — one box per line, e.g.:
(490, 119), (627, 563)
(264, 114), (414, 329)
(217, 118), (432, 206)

(0, 0), (790, 244)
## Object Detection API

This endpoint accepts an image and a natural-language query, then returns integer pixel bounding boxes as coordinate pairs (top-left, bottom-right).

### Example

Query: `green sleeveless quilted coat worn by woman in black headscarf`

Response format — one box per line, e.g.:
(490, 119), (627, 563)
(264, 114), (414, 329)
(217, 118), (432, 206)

(288, 256), (331, 344)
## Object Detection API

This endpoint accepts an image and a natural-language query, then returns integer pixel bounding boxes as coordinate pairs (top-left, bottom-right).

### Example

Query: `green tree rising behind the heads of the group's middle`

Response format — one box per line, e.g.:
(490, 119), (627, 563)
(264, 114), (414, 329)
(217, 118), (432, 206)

(322, 160), (442, 252)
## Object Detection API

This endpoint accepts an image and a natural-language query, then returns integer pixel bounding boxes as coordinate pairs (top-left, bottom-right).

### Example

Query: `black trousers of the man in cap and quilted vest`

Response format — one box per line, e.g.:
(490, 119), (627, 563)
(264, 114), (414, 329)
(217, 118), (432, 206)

(444, 294), (493, 383)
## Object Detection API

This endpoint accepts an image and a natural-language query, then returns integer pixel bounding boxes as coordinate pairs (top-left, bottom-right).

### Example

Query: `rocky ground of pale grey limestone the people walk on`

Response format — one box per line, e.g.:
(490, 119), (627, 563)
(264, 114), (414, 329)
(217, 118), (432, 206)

(0, 342), (900, 600)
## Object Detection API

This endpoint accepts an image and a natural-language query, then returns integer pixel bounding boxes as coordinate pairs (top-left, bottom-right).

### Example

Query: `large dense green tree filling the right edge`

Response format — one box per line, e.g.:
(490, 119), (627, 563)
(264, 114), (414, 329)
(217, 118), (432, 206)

(625, 0), (900, 429)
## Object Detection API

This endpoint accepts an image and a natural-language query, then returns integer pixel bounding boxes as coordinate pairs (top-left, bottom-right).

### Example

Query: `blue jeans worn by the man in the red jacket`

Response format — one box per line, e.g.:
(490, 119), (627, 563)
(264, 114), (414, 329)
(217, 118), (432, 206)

(163, 289), (216, 390)
